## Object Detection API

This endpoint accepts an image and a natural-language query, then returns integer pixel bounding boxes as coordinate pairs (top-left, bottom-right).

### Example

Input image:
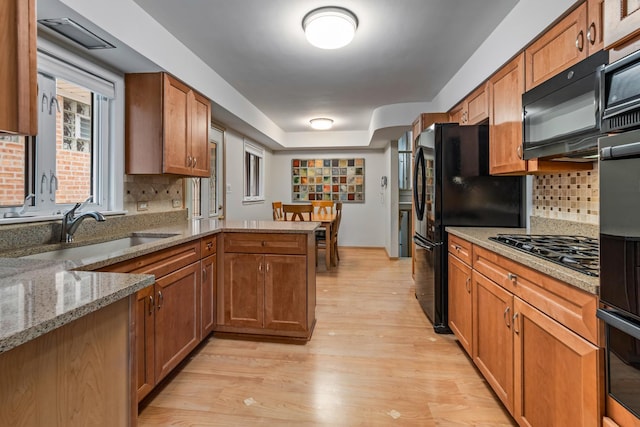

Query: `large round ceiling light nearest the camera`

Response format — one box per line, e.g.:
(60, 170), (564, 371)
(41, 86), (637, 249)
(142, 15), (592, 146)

(302, 6), (358, 49)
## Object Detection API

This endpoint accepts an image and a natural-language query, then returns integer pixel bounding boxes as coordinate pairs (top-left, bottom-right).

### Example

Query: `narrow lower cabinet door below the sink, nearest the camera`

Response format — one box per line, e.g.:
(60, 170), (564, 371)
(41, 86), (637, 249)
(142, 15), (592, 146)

(133, 286), (156, 402)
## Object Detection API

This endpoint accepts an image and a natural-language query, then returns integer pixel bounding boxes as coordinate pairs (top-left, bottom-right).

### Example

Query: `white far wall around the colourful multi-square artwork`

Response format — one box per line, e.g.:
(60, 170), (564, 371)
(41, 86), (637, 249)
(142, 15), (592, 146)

(267, 150), (389, 247)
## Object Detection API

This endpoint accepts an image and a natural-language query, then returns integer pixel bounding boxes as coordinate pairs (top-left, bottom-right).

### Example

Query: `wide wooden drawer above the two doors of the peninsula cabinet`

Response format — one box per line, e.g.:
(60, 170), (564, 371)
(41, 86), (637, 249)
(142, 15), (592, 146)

(224, 233), (307, 255)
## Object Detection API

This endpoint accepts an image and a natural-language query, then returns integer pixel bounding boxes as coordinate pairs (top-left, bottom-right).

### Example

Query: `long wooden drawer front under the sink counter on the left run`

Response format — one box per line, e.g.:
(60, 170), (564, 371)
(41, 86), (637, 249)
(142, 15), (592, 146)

(101, 240), (200, 279)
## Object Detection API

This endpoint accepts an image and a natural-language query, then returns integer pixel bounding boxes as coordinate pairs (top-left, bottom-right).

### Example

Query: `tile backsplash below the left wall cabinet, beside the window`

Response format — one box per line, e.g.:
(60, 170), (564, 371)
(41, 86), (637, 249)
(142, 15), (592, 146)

(124, 175), (184, 214)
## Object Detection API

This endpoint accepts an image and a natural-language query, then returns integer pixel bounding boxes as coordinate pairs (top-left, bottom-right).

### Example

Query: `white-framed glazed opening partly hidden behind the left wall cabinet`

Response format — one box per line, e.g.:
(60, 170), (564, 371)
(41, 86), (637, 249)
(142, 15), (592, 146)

(190, 123), (224, 218)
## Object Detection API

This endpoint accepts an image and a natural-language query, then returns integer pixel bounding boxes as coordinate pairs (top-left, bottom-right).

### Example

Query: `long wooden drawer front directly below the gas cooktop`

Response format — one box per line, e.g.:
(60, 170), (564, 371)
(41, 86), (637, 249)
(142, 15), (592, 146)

(473, 246), (598, 345)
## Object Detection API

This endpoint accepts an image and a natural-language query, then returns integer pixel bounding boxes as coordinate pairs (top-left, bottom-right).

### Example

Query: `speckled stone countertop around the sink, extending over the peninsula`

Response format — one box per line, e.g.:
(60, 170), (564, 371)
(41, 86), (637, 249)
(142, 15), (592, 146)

(0, 219), (320, 353)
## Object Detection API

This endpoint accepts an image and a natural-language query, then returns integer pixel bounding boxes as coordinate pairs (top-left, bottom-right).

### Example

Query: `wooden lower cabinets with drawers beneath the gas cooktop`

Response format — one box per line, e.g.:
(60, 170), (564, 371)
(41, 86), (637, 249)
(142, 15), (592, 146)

(449, 236), (604, 427)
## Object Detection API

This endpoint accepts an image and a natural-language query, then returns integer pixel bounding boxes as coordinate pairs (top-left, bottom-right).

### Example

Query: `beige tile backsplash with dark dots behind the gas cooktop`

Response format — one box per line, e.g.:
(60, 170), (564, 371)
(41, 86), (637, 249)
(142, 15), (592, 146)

(532, 163), (600, 224)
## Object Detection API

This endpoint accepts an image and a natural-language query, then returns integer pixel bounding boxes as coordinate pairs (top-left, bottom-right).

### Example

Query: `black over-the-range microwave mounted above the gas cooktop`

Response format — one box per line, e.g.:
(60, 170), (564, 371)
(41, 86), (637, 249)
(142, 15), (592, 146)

(522, 51), (609, 160)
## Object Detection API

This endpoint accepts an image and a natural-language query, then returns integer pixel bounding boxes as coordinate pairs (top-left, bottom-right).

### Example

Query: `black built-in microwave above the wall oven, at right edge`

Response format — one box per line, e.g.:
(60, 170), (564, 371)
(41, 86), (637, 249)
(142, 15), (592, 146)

(600, 51), (640, 132)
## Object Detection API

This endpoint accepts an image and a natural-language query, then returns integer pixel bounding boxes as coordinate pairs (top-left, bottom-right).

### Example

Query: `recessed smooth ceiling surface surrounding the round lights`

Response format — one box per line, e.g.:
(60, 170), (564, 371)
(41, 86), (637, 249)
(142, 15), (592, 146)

(129, 0), (518, 132)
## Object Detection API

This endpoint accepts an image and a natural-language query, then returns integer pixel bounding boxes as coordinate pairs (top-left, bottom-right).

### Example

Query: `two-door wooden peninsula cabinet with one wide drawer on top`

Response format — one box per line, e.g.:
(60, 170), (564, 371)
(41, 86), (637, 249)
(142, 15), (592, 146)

(216, 233), (315, 339)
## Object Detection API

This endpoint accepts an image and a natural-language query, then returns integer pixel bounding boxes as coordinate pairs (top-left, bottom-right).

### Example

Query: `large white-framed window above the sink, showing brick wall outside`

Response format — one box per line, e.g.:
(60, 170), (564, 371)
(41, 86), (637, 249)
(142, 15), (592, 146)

(0, 40), (124, 221)
